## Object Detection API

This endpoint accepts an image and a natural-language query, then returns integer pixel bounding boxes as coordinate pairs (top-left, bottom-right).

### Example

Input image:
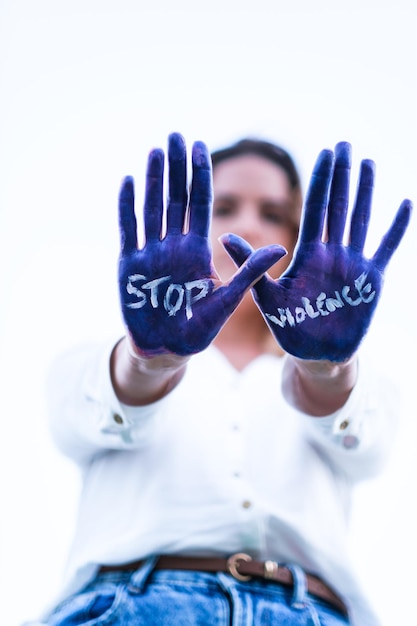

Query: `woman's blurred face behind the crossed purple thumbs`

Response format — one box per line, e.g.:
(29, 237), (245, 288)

(211, 154), (297, 281)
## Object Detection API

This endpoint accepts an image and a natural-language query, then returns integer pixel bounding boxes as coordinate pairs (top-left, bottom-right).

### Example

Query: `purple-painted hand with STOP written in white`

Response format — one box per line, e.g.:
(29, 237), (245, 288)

(119, 133), (285, 356)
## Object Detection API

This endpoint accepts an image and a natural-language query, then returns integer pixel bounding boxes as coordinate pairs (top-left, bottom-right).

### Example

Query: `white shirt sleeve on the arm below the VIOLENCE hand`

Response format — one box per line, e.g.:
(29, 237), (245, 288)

(302, 356), (400, 481)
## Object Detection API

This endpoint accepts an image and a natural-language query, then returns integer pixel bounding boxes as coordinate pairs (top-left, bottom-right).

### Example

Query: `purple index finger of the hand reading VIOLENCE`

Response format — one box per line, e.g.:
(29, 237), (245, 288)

(299, 150), (334, 243)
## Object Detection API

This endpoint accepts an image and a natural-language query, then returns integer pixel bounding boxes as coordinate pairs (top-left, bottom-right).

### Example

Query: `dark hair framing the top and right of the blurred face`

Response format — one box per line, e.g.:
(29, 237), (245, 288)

(211, 137), (302, 236)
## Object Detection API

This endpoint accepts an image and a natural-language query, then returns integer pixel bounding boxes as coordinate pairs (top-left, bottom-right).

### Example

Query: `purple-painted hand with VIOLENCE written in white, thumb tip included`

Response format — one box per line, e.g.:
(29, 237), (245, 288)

(222, 142), (412, 362)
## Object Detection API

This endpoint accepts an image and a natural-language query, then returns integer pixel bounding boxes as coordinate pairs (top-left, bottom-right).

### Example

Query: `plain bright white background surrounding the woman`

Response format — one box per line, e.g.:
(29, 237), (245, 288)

(0, 0), (417, 626)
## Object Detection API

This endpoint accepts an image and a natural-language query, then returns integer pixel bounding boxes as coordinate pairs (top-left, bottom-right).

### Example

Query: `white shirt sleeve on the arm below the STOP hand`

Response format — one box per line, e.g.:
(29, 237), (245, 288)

(47, 341), (164, 465)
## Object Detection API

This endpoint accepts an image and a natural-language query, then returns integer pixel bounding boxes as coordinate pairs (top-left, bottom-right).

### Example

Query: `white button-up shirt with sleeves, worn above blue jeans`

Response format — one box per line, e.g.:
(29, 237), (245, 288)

(49, 346), (395, 626)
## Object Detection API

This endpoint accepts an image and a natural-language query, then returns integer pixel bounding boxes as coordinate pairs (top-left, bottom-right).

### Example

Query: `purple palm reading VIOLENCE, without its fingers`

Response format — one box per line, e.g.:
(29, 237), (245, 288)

(255, 243), (382, 361)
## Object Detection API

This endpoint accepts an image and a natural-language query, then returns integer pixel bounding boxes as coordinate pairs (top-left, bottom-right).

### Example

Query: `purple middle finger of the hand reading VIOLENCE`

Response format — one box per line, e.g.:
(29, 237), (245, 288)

(327, 141), (352, 244)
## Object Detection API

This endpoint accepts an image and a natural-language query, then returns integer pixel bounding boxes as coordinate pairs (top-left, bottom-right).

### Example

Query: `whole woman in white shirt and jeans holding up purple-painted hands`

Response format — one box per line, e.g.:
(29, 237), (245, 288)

(41, 129), (411, 626)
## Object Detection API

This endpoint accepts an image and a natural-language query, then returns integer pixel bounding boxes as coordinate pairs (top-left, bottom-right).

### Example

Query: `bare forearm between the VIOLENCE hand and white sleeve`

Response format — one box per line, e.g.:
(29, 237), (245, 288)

(282, 356), (357, 417)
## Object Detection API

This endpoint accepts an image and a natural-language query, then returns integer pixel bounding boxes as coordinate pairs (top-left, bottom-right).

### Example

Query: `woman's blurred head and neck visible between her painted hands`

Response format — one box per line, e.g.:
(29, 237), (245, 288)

(211, 139), (302, 370)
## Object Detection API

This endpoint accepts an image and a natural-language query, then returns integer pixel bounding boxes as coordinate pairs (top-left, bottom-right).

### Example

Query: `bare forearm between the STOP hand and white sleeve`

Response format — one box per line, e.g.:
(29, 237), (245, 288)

(110, 337), (189, 406)
